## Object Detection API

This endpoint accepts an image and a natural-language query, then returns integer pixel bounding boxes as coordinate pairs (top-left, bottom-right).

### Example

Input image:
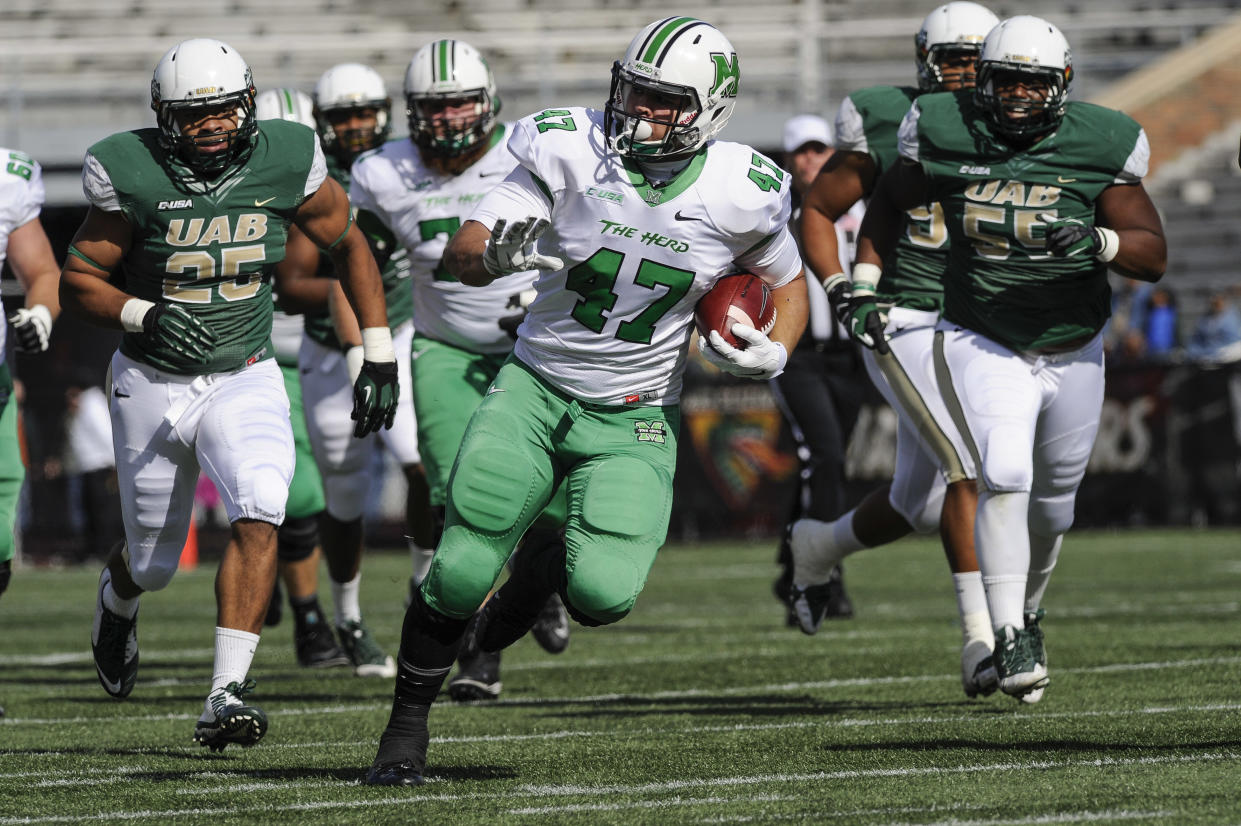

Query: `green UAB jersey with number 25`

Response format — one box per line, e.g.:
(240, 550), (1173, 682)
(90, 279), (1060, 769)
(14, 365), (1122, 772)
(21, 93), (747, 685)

(84, 120), (321, 375)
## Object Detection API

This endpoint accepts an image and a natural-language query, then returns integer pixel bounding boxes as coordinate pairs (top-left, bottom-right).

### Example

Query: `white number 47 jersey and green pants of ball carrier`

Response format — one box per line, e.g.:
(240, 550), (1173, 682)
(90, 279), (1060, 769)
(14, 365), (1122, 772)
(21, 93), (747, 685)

(423, 108), (802, 623)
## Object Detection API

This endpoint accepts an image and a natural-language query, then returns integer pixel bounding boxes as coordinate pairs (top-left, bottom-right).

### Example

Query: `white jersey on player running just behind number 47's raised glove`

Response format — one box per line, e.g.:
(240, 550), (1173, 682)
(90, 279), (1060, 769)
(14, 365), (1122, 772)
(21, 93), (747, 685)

(349, 127), (535, 353)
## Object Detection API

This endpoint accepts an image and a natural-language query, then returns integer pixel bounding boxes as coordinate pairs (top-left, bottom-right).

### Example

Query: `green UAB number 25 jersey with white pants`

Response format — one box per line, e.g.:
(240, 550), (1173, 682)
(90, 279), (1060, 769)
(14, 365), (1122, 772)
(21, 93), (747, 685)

(82, 120), (312, 590)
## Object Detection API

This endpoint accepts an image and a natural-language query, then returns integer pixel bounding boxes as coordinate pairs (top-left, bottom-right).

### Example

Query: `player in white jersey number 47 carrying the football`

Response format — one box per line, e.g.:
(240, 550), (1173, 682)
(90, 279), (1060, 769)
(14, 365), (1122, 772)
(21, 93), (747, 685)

(366, 17), (807, 785)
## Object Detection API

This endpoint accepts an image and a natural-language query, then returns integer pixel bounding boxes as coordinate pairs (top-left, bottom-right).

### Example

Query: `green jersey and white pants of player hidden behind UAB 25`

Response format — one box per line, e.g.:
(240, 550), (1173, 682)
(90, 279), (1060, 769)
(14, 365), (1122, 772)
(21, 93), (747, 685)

(298, 149), (422, 522)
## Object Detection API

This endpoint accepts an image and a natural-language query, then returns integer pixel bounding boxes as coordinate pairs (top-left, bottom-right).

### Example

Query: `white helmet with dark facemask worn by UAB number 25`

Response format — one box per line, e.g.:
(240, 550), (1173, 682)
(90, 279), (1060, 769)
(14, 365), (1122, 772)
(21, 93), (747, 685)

(151, 37), (258, 177)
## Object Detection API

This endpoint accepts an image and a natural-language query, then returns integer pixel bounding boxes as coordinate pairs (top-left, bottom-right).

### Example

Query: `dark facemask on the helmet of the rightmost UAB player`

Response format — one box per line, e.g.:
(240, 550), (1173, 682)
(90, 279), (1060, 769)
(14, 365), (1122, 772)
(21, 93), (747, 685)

(974, 62), (1069, 144)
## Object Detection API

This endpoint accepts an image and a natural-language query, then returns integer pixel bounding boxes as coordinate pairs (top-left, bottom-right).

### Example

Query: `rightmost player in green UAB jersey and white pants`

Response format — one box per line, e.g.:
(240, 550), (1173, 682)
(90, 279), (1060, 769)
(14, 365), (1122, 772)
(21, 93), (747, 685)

(858, 16), (1167, 702)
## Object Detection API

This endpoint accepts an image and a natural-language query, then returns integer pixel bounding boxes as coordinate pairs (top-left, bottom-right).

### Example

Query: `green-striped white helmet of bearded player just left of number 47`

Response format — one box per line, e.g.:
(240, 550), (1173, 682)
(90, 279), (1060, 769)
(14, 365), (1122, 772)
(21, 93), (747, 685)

(405, 40), (500, 158)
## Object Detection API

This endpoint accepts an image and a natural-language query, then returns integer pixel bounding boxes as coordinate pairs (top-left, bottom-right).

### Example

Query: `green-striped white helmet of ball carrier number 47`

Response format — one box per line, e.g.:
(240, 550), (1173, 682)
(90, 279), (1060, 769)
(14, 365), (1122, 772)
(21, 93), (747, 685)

(604, 17), (741, 159)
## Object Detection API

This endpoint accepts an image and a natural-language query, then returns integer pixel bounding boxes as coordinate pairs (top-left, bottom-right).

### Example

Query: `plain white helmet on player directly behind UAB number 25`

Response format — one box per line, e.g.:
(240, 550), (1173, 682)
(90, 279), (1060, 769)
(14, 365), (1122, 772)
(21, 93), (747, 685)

(314, 63), (392, 164)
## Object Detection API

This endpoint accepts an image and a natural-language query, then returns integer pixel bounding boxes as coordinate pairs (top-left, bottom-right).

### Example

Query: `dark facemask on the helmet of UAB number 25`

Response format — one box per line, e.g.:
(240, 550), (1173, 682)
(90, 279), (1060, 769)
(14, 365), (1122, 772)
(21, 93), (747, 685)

(151, 84), (258, 179)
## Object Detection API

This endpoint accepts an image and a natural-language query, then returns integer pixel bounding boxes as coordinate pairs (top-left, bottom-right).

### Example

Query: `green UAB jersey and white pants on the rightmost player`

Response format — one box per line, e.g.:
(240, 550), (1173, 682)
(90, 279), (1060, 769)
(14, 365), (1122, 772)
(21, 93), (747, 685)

(900, 92), (1149, 533)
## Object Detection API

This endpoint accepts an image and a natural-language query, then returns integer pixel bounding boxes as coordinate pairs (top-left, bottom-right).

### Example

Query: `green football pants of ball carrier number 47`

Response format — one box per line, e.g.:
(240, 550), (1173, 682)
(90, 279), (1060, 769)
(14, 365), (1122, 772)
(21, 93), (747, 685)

(422, 357), (680, 624)
